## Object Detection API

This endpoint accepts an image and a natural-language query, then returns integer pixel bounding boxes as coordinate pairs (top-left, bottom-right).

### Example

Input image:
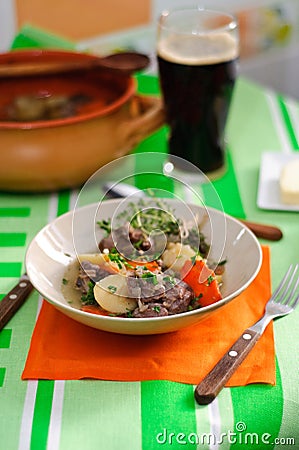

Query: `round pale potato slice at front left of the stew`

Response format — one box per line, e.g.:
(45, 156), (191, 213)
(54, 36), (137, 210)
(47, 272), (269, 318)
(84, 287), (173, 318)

(93, 274), (137, 314)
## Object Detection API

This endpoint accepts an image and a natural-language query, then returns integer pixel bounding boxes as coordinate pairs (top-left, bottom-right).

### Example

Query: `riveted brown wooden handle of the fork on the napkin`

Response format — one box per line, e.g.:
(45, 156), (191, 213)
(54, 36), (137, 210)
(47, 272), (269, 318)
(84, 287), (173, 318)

(194, 329), (260, 405)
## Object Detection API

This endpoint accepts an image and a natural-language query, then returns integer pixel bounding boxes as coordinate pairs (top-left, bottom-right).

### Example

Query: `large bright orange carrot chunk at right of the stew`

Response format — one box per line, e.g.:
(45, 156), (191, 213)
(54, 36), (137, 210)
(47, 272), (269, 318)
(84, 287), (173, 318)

(181, 260), (222, 306)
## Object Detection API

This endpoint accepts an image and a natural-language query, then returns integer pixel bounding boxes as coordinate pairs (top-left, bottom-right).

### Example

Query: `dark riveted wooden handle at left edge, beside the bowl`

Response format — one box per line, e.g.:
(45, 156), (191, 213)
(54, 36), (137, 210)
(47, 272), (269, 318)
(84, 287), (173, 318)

(0, 275), (33, 330)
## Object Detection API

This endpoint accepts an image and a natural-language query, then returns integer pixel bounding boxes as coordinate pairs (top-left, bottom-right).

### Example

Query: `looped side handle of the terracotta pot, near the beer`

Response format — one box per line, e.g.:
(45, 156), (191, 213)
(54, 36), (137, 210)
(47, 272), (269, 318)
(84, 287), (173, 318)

(118, 95), (165, 156)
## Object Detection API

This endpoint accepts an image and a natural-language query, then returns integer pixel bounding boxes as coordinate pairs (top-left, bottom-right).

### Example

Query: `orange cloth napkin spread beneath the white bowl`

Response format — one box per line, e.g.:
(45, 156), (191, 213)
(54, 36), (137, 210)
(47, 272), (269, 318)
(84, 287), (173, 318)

(22, 247), (275, 386)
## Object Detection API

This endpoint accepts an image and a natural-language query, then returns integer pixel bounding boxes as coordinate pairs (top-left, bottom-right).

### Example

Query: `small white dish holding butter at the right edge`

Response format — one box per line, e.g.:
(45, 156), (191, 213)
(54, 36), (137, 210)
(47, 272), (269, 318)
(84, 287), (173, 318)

(257, 152), (299, 211)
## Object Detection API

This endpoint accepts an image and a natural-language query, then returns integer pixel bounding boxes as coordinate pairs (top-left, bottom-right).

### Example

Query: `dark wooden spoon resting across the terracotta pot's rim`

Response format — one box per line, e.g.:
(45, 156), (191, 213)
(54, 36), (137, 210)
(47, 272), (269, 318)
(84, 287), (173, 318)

(0, 52), (150, 78)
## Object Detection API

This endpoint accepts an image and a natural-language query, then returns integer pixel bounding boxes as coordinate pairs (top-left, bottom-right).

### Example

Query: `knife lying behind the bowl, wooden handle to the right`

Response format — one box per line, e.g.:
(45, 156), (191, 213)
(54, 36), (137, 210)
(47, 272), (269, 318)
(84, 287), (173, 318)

(103, 183), (283, 241)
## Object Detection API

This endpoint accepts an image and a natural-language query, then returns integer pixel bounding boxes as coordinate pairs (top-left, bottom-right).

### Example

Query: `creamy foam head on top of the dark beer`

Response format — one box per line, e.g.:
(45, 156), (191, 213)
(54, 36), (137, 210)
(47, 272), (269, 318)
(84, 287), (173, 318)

(157, 32), (239, 65)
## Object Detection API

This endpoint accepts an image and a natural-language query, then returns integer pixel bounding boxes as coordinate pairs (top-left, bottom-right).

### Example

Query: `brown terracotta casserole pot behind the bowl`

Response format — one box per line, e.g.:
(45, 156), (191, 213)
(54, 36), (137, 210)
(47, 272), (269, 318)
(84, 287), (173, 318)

(0, 50), (164, 192)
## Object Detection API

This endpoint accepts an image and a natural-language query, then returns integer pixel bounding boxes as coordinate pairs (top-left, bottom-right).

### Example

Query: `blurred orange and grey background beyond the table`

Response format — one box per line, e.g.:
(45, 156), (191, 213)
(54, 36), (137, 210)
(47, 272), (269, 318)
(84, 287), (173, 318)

(0, 0), (299, 99)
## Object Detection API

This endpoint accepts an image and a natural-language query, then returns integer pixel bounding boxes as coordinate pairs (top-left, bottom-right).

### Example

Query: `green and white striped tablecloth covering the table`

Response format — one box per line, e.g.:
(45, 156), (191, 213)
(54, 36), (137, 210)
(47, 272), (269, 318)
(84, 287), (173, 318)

(0, 76), (299, 450)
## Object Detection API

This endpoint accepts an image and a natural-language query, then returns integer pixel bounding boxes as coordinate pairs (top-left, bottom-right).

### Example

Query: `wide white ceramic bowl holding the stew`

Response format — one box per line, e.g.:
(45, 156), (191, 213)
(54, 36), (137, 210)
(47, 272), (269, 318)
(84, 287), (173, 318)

(26, 199), (262, 335)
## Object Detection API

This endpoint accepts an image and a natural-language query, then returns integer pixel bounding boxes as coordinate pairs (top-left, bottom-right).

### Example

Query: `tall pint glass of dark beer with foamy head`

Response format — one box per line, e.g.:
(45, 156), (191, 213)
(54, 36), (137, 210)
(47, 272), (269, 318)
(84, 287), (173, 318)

(157, 9), (239, 179)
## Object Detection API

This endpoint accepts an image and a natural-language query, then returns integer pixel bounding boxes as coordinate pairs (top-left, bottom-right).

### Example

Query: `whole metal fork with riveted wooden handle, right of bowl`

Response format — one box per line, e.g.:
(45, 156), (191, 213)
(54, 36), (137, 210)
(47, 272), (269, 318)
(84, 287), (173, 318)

(194, 264), (299, 405)
